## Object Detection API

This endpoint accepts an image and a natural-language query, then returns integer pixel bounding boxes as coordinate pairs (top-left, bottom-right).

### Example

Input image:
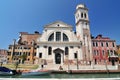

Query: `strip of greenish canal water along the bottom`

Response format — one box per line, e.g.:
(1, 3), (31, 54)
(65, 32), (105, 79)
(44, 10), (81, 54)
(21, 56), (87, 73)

(0, 73), (120, 79)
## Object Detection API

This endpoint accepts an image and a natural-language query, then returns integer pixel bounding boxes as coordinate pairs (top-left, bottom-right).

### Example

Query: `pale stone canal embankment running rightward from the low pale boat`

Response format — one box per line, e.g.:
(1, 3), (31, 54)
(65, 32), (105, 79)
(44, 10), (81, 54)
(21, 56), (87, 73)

(46, 65), (120, 74)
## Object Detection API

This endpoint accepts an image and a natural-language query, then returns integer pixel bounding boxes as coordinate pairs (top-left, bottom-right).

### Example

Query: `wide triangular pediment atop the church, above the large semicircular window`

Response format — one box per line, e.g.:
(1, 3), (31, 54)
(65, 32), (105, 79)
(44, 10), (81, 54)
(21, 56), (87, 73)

(45, 21), (72, 28)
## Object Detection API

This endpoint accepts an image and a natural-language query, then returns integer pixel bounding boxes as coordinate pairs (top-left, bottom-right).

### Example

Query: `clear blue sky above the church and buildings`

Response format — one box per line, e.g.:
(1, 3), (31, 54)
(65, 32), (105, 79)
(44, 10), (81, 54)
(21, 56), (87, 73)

(0, 0), (120, 49)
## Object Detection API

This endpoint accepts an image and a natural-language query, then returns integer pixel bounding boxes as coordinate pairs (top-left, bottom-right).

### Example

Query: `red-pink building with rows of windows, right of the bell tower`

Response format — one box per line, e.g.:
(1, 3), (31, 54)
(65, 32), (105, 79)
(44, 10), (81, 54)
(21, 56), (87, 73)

(92, 35), (118, 65)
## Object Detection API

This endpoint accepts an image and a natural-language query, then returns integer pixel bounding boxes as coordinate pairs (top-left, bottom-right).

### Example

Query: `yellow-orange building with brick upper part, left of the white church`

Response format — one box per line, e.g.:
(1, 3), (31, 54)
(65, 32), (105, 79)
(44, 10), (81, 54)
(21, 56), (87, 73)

(7, 32), (41, 64)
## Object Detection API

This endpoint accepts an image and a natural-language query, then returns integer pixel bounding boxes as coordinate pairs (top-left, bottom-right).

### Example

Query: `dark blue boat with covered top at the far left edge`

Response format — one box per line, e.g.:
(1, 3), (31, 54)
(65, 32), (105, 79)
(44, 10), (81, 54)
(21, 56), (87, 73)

(0, 67), (14, 76)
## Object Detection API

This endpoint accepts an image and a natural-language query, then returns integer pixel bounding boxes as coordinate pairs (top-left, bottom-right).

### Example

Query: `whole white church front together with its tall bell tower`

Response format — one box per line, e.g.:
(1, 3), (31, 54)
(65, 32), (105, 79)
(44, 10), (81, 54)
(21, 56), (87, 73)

(35, 4), (92, 65)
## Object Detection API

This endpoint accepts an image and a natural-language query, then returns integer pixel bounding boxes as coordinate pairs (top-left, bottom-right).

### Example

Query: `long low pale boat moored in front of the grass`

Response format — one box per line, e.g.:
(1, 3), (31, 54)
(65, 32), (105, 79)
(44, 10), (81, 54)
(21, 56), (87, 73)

(22, 70), (51, 76)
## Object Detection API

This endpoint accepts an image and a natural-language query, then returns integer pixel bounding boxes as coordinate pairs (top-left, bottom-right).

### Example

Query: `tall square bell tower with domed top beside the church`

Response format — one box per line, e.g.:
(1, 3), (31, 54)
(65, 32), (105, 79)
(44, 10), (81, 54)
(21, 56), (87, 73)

(75, 4), (92, 64)
